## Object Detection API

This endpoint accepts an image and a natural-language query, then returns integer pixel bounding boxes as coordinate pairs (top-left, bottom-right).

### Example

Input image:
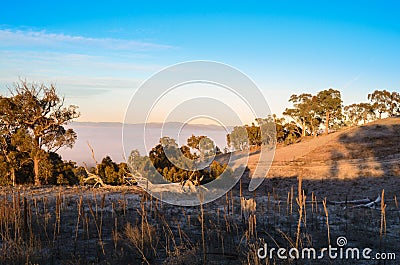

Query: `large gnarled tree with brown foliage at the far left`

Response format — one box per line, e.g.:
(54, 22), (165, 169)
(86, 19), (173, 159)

(0, 81), (79, 185)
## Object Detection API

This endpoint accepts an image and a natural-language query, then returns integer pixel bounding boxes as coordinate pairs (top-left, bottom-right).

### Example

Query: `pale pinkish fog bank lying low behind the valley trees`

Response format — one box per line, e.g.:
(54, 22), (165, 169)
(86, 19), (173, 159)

(58, 122), (231, 165)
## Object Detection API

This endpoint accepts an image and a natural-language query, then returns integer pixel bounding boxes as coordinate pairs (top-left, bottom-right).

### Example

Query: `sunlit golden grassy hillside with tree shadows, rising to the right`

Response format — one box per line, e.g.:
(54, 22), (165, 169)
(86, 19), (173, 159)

(244, 118), (400, 179)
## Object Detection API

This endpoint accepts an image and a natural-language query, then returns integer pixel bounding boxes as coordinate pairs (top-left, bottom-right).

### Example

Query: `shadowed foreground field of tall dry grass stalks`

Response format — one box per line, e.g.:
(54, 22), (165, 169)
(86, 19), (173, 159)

(0, 179), (400, 264)
